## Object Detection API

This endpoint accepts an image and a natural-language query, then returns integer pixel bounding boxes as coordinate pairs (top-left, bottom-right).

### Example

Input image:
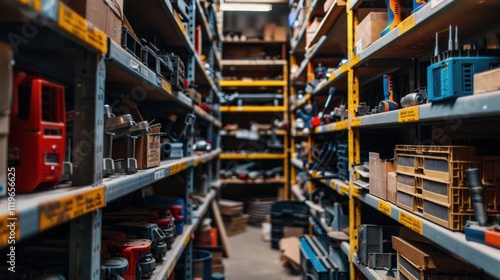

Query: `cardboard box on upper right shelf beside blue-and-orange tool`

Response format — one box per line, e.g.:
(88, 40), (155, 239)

(354, 12), (387, 54)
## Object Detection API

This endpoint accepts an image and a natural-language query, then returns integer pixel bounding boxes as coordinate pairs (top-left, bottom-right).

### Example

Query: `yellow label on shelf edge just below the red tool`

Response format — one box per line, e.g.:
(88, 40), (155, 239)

(39, 186), (105, 230)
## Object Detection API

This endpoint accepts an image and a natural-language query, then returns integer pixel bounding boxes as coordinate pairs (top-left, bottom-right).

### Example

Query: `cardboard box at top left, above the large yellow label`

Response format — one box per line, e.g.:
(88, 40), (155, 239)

(67, 0), (123, 45)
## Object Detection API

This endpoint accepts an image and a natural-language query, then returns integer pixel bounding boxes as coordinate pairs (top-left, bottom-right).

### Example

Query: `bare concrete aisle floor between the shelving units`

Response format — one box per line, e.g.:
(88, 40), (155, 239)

(224, 225), (301, 280)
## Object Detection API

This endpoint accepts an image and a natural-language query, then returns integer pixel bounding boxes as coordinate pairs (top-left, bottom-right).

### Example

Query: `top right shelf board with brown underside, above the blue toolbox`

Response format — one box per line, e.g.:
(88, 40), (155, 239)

(352, 0), (500, 67)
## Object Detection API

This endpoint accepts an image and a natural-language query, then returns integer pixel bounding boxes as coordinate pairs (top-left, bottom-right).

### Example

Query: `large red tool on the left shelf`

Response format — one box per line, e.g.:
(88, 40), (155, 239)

(8, 71), (66, 192)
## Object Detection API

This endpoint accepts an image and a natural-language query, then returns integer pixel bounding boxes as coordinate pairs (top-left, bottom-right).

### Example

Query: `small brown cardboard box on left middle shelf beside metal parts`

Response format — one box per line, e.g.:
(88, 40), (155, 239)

(135, 126), (161, 169)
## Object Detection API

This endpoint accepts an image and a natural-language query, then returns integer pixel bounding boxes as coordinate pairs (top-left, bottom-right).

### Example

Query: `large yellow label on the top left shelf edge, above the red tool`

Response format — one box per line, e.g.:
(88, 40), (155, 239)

(57, 2), (108, 53)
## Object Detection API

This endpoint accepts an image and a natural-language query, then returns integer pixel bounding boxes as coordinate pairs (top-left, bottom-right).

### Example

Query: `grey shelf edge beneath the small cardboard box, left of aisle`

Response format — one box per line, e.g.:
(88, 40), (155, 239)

(102, 149), (221, 202)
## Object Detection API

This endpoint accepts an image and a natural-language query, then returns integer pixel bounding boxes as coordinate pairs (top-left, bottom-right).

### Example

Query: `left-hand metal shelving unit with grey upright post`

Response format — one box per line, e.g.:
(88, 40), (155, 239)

(0, 0), (222, 279)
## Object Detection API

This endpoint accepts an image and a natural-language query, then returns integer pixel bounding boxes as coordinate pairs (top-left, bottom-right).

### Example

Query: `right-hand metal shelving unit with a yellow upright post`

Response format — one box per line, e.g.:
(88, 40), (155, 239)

(290, 0), (500, 279)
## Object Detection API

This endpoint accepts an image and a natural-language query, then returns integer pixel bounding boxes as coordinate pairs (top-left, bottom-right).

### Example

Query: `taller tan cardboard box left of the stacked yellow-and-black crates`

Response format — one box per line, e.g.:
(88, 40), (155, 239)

(370, 152), (394, 200)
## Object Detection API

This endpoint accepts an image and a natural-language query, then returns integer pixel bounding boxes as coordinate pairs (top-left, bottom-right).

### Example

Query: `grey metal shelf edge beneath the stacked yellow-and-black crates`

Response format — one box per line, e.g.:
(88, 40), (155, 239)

(358, 193), (500, 275)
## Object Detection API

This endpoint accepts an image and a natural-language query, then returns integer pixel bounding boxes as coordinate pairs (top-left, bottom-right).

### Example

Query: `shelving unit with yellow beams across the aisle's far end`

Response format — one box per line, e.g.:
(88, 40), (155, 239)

(219, 36), (289, 197)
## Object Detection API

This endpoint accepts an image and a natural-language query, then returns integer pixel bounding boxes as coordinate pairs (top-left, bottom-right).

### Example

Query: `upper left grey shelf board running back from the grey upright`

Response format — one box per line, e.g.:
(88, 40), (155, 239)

(106, 40), (192, 109)
